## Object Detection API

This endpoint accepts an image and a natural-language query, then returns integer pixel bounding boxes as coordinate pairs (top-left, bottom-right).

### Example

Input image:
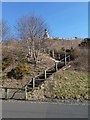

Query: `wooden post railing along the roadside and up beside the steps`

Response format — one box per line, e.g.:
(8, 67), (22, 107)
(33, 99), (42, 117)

(1, 55), (70, 100)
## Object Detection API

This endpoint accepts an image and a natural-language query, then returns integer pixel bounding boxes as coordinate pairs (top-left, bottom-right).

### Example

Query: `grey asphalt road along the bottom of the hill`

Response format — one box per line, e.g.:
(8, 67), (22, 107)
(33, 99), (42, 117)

(2, 101), (88, 118)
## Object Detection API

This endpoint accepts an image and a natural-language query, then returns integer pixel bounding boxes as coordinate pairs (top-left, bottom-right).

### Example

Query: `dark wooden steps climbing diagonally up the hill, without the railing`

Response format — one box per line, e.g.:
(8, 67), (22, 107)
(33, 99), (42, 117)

(27, 55), (70, 90)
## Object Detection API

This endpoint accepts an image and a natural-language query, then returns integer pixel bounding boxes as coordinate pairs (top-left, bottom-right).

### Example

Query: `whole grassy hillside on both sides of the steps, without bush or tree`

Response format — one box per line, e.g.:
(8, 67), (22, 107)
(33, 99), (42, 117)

(2, 40), (89, 99)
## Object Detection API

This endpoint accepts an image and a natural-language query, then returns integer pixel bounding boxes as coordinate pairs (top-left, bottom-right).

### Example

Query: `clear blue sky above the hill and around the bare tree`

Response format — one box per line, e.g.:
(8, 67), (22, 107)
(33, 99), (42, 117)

(2, 2), (88, 38)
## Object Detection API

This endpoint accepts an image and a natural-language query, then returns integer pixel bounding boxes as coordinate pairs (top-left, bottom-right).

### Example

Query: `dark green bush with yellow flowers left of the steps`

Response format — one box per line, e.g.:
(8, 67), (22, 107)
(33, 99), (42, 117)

(7, 64), (29, 79)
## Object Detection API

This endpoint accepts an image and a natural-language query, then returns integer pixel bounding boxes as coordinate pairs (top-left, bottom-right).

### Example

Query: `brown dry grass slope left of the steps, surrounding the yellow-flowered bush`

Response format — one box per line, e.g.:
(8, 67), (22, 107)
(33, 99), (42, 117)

(2, 41), (53, 88)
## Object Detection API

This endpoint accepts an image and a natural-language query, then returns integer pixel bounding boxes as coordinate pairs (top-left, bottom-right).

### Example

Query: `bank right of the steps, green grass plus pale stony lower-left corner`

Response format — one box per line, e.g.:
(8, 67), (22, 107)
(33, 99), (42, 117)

(28, 70), (89, 100)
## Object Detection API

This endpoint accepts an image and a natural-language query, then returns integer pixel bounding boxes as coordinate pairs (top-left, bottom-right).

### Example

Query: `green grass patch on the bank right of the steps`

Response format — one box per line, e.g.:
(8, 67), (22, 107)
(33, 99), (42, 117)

(45, 70), (88, 99)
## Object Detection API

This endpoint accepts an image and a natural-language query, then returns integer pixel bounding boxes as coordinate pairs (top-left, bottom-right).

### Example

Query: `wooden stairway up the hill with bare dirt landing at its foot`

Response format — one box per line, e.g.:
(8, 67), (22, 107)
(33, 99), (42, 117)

(6, 55), (70, 99)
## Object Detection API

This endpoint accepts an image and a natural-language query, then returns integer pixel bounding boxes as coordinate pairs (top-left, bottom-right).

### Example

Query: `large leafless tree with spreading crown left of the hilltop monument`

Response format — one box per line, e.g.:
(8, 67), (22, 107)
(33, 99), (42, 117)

(16, 15), (46, 65)
